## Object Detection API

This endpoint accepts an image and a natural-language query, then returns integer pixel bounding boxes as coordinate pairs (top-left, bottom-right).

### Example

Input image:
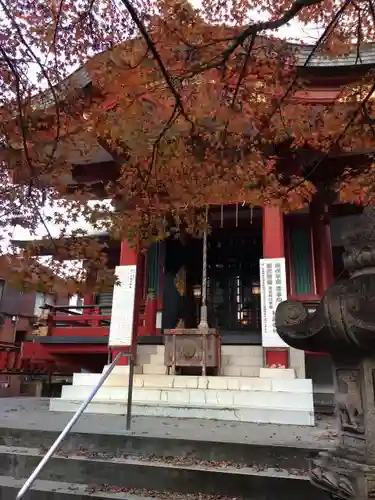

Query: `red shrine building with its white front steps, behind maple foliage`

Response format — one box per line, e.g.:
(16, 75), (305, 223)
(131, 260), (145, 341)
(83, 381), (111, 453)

(10, 45), (375, 425)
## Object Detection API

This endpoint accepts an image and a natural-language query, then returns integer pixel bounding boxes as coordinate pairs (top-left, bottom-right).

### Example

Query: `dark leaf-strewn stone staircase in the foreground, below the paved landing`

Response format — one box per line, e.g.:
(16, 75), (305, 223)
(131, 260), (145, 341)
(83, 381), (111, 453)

(0, 417), (325, 500)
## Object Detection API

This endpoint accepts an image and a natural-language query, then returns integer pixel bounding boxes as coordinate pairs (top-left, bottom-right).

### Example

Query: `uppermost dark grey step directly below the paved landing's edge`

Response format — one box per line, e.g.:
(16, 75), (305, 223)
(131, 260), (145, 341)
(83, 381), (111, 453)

(0, 419), (324, 473)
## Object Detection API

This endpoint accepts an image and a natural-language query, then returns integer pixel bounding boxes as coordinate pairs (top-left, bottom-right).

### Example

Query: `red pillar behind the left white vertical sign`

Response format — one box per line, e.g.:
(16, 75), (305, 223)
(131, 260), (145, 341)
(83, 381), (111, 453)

(111, 240), (141, 366)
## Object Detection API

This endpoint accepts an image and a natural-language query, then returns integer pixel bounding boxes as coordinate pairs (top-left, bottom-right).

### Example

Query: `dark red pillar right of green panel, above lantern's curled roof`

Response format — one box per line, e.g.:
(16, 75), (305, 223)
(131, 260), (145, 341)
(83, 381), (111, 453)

(310, 203), (334, 296)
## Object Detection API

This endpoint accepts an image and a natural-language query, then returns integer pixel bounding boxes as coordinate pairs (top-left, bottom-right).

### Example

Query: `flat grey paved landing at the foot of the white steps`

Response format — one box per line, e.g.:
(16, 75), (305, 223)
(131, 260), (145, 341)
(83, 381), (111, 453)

(0, 398), (336, 448)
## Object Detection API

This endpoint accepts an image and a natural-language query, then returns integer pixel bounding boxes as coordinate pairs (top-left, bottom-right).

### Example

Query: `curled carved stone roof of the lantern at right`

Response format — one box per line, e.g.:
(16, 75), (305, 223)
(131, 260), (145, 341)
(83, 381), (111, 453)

(275, 209), (375, 357)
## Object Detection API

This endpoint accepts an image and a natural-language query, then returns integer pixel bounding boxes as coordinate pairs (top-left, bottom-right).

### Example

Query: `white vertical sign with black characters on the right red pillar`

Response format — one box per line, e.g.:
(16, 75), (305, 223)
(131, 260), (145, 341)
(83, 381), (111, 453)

(260, 258), (287, 347)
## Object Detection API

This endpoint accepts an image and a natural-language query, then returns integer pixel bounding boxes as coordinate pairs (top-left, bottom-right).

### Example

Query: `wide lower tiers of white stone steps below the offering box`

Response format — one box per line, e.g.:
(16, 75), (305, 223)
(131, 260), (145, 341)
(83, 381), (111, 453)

(50, 367), (314, 425)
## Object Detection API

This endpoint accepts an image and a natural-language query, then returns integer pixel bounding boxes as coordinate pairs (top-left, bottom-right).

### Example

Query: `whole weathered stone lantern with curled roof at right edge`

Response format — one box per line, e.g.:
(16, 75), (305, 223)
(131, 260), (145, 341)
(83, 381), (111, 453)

(275, 208), (375, 500)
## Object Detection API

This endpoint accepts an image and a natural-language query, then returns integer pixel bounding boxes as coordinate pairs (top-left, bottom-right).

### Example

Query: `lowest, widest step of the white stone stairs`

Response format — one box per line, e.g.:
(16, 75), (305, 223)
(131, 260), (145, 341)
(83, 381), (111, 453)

(50, 391), (314, 425)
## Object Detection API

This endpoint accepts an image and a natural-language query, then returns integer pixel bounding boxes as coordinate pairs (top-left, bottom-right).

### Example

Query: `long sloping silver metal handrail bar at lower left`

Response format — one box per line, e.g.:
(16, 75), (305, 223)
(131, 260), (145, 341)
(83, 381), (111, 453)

(16, 352), (124, 500)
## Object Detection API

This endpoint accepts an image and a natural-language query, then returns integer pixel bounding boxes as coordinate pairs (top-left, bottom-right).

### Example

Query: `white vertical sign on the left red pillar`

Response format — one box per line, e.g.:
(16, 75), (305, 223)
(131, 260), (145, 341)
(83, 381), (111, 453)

(108, 266), (137, 346)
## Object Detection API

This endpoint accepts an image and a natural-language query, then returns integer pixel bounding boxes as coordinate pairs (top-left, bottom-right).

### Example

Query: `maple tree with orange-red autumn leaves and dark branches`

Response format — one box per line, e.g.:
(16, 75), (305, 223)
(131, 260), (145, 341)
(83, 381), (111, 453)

(0, 0), (375, 287)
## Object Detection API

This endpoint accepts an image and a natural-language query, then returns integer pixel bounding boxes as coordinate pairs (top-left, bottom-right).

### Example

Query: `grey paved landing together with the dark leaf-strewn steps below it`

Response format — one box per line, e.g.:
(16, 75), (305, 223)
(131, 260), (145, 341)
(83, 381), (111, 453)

(0, 398), (336, 500)
